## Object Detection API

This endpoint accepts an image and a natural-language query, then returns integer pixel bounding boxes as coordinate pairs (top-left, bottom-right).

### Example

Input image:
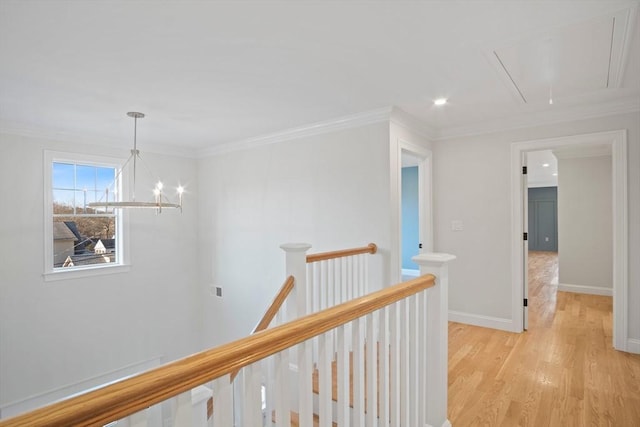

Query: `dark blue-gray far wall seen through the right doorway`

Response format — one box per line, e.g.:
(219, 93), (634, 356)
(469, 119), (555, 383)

(529, 187), (558, 252)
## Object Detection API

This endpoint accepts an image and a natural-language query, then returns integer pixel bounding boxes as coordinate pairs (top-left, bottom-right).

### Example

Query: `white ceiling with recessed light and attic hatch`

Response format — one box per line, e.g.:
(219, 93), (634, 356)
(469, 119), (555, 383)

(0, 0), (640, 153)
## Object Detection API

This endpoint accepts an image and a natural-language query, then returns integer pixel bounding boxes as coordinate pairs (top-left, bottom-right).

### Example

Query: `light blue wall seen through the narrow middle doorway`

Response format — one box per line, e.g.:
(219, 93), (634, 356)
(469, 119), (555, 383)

(402, 166), (420, 270)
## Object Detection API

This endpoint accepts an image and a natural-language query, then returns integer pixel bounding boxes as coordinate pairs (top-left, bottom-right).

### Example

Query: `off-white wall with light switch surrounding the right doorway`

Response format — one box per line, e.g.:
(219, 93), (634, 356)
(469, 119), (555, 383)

(433, 113), (640, 340)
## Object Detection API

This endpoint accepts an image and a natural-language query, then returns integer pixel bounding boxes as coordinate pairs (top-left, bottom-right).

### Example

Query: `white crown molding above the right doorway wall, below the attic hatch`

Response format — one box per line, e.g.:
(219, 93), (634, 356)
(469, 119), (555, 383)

(434, 96), (640, 141)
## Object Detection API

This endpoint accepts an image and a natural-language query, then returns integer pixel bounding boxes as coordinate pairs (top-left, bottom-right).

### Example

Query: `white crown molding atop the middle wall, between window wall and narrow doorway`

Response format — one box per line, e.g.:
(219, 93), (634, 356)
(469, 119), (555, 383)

(198, 107), (392, 157)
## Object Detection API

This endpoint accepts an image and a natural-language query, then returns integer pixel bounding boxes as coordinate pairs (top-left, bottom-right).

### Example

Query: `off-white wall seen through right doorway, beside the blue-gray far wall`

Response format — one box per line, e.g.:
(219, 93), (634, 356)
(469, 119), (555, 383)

(558, 156), (613, 294)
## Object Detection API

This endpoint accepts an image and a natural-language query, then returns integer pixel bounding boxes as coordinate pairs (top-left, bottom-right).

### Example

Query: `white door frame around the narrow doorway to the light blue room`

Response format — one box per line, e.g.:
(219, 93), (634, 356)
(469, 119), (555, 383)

(390, 138), (433, 282)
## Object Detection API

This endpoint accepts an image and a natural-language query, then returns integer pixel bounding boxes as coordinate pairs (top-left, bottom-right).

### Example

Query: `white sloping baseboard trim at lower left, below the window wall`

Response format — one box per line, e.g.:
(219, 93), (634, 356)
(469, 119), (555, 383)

(0, 356), (163, 419)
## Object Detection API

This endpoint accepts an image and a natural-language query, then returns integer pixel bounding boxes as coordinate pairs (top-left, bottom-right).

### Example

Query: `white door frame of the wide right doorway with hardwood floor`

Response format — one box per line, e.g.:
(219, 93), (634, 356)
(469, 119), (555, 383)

(511, 129), (629, 351)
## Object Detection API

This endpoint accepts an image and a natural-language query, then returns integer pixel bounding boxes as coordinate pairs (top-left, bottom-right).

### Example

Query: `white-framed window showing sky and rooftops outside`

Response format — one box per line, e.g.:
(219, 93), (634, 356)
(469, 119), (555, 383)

(45, 152), (125, 279)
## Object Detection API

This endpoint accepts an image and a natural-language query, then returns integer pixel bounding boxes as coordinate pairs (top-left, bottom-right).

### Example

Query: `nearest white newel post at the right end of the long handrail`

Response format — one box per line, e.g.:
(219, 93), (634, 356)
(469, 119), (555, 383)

(412, 253), (456, 427)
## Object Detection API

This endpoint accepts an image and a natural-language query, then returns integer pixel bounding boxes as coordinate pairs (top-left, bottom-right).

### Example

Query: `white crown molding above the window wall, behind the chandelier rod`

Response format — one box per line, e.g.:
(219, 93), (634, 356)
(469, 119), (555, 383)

(0, 121), (197, 159)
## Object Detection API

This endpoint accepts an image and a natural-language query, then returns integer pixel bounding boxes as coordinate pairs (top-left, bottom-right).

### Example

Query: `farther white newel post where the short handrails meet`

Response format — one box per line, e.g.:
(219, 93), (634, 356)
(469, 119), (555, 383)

(280, 243), (311, 321)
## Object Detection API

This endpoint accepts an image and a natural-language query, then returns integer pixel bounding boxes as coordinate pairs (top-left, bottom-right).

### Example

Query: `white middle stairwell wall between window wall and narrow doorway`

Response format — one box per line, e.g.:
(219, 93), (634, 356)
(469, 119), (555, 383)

(198, 123), (390, 346)
